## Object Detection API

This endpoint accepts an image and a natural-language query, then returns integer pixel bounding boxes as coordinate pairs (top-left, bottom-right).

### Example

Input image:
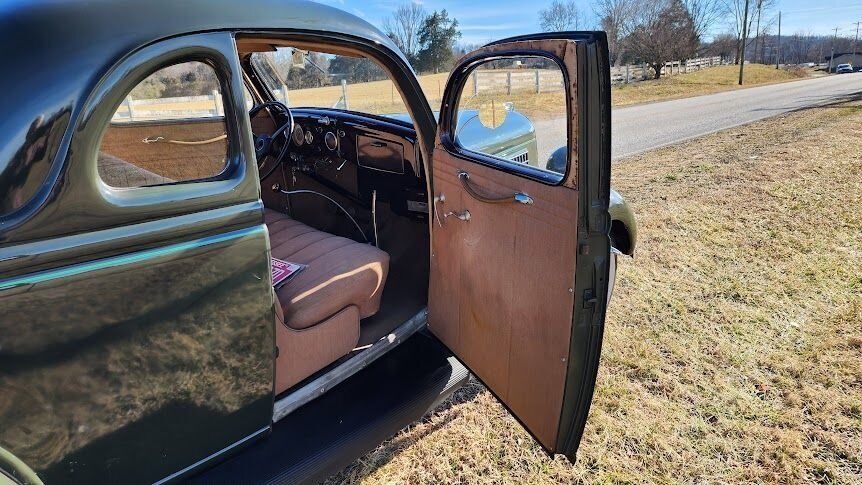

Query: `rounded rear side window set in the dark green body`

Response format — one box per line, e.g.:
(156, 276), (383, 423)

(98, 61), (227, 188)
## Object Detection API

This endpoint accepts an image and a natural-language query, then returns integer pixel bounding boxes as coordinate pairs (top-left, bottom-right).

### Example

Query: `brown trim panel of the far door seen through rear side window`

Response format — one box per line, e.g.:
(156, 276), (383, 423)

(100, 118), (227, 183)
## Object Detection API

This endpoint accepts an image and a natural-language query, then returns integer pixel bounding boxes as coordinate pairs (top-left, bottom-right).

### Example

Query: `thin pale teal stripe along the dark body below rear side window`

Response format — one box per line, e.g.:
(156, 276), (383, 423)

(0, 225), (266, 291)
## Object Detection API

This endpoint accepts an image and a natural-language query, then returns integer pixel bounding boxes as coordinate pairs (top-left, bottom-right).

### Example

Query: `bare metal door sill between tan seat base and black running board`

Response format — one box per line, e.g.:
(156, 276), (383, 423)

(272, 308), (428, 423)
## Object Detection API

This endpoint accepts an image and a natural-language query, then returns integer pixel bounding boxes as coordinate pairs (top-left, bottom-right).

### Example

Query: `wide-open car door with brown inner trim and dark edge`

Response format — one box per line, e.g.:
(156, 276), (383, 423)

(428, 33), (610, 458)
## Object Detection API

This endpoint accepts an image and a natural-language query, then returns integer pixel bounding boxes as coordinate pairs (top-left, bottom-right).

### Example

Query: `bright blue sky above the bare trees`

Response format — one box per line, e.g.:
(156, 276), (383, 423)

(316, 0), (862, 44)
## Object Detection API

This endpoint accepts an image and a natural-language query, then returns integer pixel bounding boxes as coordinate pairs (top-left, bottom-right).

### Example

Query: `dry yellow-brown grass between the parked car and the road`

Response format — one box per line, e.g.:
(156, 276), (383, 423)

(330, 96), (862, 484)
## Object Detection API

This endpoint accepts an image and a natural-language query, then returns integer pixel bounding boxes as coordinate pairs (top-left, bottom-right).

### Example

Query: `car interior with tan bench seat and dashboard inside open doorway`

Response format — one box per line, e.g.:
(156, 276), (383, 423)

(238, 39), (429, 395)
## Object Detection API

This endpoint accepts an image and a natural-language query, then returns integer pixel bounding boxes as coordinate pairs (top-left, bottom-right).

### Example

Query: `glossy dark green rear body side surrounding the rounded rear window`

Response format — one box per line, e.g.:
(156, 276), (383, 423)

(0, 32), (275, 483)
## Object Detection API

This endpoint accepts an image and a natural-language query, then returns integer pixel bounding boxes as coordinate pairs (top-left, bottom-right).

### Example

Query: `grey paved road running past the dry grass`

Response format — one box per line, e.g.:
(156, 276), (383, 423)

(536, 73), (862, 159)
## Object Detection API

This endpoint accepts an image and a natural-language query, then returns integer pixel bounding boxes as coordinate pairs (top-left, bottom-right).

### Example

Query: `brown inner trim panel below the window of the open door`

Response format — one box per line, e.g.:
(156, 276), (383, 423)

(428, 148), (578, 448)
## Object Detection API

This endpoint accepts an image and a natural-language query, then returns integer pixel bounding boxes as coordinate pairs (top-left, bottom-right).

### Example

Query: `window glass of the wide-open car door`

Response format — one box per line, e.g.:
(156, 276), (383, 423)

(455, 57), (569, 179)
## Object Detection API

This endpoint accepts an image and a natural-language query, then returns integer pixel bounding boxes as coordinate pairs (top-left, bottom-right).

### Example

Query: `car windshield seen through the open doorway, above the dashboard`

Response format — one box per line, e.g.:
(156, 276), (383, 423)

(251, 47), (414, 120)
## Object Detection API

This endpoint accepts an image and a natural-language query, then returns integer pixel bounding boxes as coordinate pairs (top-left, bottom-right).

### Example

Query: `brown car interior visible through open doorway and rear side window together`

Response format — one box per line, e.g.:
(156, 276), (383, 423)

(97, 38), (429, 395)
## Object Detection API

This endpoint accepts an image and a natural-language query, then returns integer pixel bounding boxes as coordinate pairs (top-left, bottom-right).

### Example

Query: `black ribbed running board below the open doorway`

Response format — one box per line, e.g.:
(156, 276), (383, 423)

(189, 332), (469, 485)
